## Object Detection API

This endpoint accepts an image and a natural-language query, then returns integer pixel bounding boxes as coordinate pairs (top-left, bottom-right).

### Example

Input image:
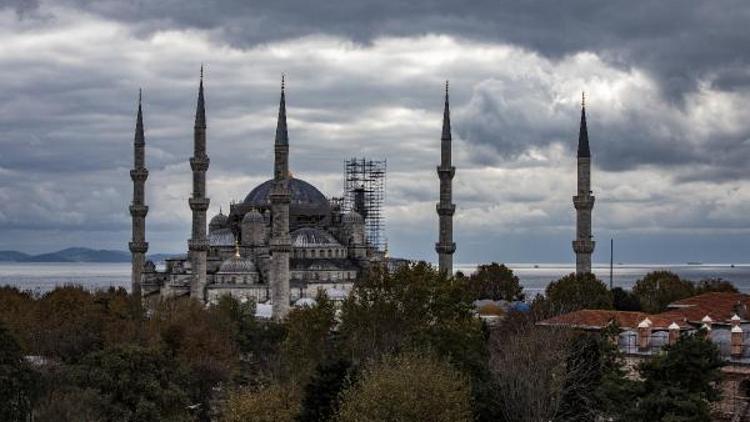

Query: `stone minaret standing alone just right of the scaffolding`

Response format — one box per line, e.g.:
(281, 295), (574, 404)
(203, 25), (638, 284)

(435, 81), (456, 276)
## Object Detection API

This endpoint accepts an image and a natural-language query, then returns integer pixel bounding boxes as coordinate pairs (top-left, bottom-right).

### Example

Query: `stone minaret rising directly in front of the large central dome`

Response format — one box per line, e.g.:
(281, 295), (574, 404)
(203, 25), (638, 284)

(269, 75), (292, 320)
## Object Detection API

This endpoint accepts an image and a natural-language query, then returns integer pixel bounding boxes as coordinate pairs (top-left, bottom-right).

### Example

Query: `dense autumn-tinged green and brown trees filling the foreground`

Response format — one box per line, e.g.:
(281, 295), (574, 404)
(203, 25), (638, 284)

(0, 263), (733, 422)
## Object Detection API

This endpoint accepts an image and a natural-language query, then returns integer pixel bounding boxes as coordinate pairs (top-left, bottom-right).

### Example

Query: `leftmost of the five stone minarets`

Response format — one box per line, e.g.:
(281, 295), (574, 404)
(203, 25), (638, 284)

(128, 90), (148, 298)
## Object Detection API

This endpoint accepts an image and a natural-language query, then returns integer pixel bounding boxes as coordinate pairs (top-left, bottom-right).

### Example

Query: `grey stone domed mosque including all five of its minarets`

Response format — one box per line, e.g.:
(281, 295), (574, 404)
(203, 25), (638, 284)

(129, 69), (593, 319)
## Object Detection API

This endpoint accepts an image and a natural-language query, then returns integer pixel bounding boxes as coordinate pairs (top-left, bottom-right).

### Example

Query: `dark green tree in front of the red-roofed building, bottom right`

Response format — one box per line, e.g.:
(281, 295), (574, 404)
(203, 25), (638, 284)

(622, 331), (725, 422)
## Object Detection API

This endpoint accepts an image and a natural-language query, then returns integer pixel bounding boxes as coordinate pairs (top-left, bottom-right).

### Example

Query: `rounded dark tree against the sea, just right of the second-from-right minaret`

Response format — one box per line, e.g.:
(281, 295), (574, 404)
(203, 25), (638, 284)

(469, 262), (524, 301)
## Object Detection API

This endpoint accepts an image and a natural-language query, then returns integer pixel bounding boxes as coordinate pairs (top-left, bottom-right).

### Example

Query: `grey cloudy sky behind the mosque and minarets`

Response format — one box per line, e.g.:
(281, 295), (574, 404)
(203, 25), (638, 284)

(0, 0), (750, 263)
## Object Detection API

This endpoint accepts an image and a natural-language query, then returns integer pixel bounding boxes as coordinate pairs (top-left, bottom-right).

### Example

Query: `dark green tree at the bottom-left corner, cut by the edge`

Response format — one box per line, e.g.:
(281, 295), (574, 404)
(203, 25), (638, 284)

(0, 323), (38, 422)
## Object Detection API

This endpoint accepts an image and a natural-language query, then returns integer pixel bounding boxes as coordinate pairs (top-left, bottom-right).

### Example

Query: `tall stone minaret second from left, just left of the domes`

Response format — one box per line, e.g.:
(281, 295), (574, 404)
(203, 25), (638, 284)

(188, 66), (209, 301)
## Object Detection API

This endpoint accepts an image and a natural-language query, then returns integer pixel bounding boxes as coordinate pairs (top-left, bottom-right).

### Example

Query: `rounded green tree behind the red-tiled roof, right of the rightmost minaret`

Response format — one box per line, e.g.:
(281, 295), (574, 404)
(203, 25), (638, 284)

(633, 271), (695, 314)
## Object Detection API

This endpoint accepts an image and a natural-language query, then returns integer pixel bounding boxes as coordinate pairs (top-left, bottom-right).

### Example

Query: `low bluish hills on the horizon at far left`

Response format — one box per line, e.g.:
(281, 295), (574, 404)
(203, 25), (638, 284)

(0, 248), (171, 262)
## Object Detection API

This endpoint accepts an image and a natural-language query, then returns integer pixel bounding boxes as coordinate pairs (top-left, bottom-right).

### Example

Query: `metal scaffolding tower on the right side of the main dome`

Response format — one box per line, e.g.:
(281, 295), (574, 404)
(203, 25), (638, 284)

(343, 158), (388, 251)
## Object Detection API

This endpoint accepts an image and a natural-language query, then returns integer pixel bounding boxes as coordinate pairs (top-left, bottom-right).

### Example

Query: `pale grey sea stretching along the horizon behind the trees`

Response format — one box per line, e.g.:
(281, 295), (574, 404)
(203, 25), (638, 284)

(0, 262), (750, 298)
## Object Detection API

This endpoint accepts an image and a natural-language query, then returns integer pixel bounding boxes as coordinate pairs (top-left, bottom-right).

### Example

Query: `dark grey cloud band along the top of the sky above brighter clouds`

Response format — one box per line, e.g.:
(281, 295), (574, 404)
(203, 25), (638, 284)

(14, 0), (750, 102)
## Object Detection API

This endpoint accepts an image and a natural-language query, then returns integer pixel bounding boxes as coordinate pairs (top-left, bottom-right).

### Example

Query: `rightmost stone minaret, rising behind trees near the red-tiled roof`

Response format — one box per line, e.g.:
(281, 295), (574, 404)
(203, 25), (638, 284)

(573, 94), (595, 274)
